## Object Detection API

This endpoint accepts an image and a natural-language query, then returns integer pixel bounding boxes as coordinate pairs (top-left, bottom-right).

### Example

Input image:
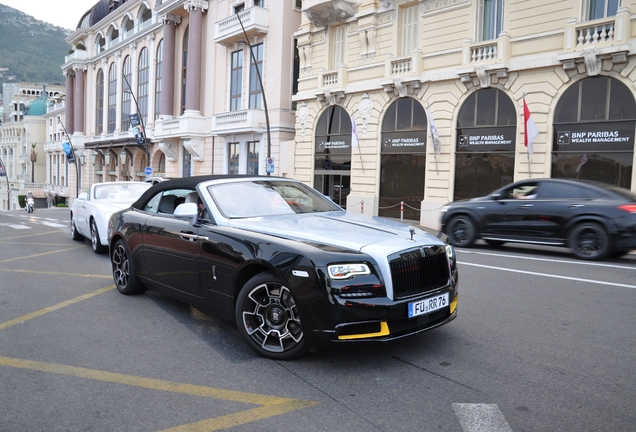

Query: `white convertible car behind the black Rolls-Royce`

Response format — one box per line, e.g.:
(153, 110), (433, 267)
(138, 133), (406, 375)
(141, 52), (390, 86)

(71, 181), (152, 253)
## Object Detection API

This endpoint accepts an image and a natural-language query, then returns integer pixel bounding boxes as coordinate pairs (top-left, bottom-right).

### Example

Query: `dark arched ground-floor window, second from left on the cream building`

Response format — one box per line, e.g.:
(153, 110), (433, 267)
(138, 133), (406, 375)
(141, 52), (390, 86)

(378, 97), (427, 220)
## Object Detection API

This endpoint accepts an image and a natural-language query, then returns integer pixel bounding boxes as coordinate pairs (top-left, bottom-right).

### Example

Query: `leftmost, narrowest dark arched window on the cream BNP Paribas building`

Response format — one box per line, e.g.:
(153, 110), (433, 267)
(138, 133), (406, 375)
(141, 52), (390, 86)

(314, 105), (351, 207)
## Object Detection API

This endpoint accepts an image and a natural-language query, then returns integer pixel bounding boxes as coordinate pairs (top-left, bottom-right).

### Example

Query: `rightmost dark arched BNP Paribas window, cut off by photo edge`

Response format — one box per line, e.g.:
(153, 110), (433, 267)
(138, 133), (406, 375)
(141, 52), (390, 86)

(552, 76), (636, 189)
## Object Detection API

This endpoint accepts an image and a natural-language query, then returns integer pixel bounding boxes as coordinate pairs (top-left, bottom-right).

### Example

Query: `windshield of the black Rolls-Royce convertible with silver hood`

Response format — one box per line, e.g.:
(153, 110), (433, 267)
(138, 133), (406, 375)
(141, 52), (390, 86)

(208, 181), (342, 218)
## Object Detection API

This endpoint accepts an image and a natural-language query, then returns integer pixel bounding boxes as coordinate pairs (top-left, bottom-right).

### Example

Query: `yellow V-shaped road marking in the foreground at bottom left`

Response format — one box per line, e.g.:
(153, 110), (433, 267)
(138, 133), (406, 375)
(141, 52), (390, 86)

(0, 357), (318, 432)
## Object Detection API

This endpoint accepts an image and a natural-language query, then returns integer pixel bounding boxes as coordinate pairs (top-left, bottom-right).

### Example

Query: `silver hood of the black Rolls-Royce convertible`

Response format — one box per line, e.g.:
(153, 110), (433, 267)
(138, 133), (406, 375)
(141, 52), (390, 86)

(228, 212), (444, 256)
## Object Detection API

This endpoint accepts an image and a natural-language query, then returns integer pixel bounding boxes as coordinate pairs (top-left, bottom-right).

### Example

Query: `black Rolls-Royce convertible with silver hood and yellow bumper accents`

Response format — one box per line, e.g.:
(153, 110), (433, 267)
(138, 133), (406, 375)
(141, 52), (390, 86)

(108, 176), (458, 359)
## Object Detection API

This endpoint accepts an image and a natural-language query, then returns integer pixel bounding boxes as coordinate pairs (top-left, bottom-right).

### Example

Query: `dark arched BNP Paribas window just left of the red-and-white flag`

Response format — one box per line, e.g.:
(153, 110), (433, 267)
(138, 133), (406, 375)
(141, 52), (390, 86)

(454, 88), (517, 200)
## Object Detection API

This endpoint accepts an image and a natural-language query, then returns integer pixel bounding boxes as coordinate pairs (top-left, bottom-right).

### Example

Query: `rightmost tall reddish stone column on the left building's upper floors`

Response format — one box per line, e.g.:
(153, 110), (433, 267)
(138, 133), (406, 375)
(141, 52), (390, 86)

(184, 0), (208, 115)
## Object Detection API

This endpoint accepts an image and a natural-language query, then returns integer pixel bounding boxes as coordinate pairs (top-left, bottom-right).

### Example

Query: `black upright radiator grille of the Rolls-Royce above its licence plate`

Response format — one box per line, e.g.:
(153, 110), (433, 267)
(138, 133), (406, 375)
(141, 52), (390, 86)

(389, 246), (450, 299)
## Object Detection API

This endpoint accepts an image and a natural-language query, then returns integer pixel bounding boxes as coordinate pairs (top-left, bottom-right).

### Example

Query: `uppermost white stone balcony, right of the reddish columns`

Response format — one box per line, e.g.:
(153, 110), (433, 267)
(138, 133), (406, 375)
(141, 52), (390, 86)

(214, 6), (269, 45)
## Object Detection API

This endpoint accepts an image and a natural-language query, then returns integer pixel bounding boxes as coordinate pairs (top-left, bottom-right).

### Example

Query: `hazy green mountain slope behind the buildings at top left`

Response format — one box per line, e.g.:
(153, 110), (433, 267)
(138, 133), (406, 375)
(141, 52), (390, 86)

(0, 4), (71, 86)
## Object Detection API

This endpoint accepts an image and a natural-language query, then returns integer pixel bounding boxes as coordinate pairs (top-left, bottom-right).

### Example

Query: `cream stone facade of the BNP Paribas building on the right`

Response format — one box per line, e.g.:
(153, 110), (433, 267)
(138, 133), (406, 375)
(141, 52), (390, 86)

(288, 0), (636, 226)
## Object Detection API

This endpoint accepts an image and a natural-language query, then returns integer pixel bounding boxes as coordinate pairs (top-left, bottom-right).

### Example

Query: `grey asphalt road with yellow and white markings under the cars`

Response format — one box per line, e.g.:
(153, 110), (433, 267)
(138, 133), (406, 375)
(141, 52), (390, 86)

(0, 209), (636, 432)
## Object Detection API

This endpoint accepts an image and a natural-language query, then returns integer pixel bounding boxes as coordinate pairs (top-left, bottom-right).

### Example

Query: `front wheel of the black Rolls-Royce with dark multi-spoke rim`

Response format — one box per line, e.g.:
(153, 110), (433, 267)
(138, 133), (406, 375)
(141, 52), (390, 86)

(235, 272), (307, 360)
